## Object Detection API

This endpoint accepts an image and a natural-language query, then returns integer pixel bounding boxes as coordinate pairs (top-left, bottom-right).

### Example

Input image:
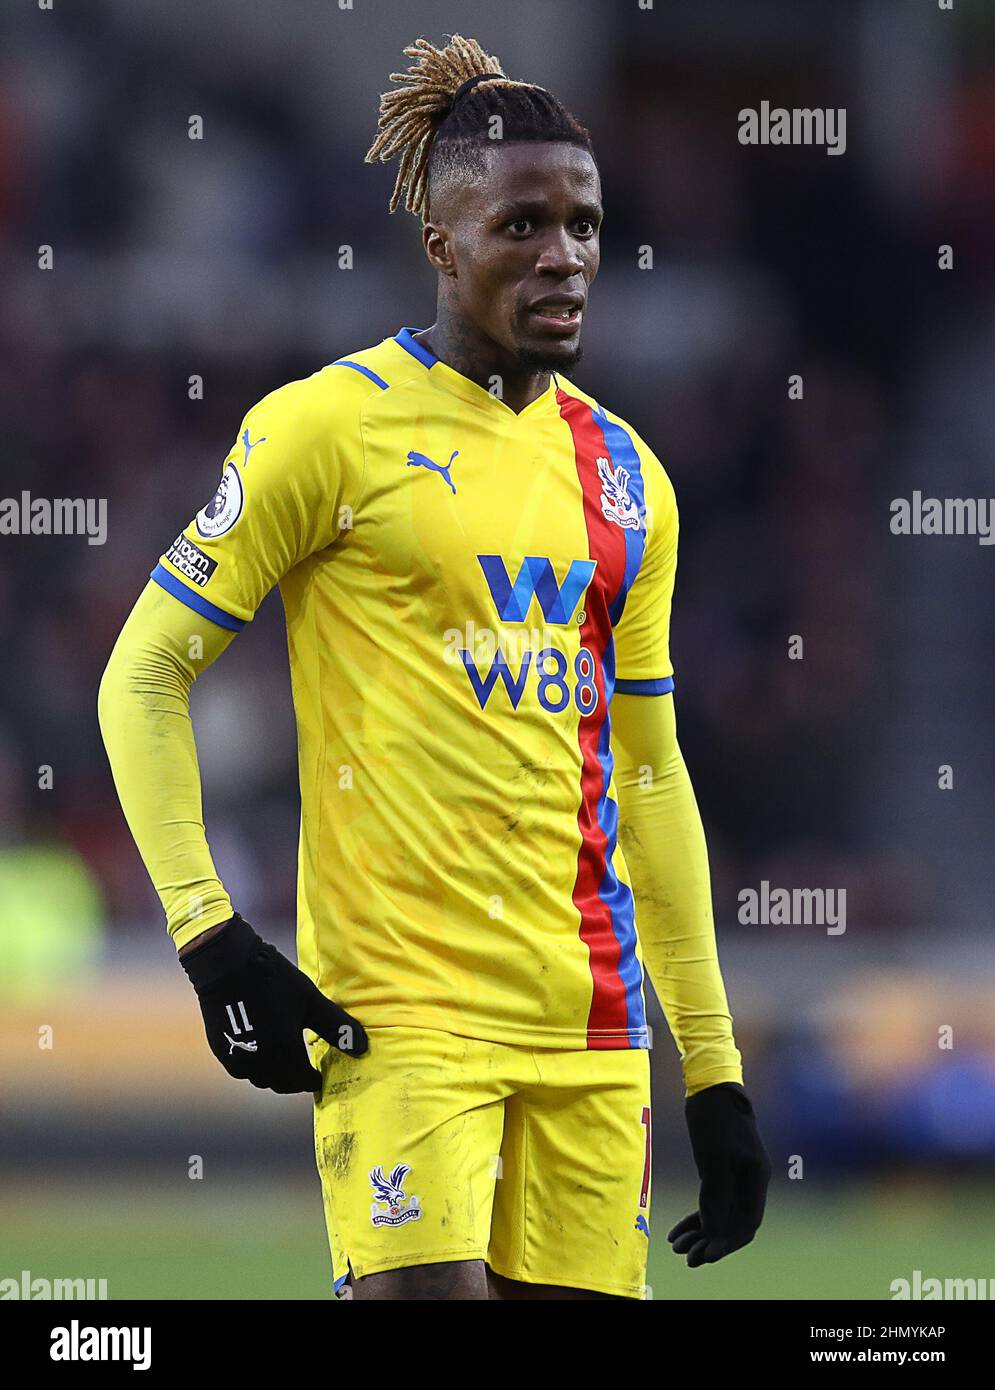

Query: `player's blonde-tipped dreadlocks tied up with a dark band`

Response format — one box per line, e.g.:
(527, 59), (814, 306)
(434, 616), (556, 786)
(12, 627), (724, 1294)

(365, 33), (593, 222)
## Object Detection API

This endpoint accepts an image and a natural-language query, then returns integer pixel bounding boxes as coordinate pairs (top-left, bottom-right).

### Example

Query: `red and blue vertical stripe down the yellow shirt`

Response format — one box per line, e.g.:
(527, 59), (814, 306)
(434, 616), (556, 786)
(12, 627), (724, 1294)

(556, 391), (649, 1048)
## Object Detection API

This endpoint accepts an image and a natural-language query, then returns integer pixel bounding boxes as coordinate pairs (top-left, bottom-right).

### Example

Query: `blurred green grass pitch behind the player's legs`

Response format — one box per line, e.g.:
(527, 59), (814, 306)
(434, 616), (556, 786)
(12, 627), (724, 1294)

(0, 1179), (995, 1300)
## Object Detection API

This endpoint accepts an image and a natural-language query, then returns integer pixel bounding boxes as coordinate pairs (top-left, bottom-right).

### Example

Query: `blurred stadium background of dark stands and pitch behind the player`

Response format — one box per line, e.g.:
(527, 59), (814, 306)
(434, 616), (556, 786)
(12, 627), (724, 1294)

(0, 0), (995, 1298)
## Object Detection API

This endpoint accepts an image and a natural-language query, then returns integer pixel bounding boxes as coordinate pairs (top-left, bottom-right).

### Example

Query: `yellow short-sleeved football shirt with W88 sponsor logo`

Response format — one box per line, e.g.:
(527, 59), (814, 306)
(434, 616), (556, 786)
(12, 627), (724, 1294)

(153, 328), (677, 1048)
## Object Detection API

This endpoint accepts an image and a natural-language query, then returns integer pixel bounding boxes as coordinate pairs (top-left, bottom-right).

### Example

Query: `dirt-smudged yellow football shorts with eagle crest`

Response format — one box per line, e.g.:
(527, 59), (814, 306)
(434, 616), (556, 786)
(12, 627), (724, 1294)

(313, 1027), (650, 1298)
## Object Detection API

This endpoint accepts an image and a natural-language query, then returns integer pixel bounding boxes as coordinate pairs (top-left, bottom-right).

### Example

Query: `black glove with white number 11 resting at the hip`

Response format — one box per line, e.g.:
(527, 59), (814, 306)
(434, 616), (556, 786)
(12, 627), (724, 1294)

(179, 912), (370, 1095)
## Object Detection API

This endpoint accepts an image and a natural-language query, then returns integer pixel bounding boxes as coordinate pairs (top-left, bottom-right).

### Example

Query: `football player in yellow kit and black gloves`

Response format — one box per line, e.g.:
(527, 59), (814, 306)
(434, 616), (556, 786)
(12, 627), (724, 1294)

(99, 35), (770, 1300)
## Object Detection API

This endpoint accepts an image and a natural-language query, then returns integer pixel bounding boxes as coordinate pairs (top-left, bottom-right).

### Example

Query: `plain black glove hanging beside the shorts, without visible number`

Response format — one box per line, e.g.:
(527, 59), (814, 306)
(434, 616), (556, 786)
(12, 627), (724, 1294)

(667, 1081), (770, 1269)
